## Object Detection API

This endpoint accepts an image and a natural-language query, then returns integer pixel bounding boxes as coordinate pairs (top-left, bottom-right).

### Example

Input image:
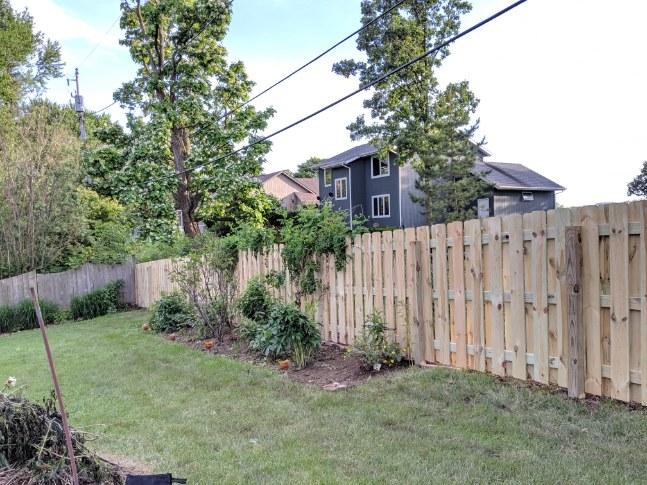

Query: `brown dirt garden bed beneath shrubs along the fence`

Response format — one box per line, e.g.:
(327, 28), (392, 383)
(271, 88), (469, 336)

(165, 328), (408, 391)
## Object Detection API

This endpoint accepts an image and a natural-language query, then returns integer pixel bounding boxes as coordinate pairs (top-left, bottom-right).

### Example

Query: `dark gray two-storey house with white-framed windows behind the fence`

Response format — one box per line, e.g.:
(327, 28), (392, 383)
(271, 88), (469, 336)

(319, 144), (564, 227)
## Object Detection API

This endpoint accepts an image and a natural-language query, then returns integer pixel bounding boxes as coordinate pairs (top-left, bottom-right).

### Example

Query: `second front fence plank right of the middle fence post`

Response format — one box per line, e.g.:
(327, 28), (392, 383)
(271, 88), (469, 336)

(447, 221), (467, 369)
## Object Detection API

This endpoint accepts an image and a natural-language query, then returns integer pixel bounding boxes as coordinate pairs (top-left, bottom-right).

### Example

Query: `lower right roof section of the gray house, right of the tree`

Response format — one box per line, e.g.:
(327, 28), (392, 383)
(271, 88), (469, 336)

(474, 162), (565, 191)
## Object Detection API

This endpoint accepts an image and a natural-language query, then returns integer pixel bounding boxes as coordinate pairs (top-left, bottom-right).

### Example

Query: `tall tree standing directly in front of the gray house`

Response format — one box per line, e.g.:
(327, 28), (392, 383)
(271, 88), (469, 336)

(333, 0), (488, 223)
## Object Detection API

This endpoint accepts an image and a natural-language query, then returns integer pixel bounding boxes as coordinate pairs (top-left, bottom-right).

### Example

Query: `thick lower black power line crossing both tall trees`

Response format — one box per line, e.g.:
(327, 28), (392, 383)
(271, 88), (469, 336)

(173, 0), (528, 181)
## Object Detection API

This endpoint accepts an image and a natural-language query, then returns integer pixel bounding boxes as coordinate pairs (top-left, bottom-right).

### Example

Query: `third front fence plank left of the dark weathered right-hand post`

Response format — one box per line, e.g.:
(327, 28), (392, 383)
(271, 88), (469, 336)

(502, 214), (527, 380)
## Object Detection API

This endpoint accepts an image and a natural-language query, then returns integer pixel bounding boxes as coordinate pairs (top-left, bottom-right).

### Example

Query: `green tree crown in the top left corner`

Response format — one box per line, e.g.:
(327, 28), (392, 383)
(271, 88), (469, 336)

(0, 0), (63, 106)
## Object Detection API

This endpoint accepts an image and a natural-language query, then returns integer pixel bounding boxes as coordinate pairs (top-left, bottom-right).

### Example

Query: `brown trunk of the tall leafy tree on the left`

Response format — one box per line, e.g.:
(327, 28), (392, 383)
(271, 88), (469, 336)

(171, 127), (200, 237)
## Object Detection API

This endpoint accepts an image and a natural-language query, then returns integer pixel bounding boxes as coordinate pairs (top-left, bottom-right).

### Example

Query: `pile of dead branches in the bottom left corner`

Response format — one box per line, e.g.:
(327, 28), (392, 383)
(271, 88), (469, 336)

(0, 392), (123, 485)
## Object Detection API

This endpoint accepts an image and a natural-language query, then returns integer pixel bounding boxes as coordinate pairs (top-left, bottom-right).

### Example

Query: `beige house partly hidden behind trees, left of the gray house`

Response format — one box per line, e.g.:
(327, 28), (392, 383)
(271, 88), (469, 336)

(258, 170), (319, 210)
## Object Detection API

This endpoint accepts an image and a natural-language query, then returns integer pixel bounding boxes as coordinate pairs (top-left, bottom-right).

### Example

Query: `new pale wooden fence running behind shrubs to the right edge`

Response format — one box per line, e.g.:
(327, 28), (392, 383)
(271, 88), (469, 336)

(239, 202), (647, 404)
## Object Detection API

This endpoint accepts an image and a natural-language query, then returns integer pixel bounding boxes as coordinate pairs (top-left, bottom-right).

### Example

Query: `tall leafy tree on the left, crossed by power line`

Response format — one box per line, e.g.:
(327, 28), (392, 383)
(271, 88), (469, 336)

(115, 0), (273, 235)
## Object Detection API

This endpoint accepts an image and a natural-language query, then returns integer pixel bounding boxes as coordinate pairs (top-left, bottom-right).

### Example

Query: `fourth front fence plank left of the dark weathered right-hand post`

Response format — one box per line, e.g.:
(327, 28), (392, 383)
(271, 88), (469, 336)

(483, 217), (505, 376)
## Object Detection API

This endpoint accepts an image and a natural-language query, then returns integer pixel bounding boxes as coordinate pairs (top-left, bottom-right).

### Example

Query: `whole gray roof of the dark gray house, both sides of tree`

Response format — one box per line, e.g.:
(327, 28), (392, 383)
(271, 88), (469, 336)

(319, 143), (565, 191)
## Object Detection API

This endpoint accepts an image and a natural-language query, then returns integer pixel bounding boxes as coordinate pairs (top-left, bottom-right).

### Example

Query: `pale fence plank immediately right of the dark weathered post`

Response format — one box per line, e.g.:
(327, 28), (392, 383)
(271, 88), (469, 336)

(579, 206), (604, 396)
